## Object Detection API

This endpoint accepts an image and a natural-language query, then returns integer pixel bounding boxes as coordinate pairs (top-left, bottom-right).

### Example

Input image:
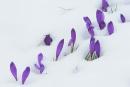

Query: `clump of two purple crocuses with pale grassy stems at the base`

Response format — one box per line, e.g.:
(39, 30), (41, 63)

(85, 37), (101, 61)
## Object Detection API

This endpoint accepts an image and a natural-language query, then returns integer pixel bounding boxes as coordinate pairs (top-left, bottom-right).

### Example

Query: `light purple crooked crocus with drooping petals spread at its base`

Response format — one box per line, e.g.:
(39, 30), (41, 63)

(35, 53), (45, 74)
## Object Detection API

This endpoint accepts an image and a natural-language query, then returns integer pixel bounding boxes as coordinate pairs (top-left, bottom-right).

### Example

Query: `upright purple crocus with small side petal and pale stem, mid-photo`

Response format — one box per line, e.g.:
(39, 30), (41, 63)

(68, 28), (76, 53)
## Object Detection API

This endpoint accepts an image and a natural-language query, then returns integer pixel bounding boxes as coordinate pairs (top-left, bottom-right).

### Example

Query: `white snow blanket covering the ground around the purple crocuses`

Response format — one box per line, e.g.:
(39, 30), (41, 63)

(0, 0), (130, 87)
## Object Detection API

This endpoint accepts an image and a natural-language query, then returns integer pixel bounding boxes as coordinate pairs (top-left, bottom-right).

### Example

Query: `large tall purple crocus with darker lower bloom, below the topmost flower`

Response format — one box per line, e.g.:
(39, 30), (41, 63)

(96, 10), (106, 30)
